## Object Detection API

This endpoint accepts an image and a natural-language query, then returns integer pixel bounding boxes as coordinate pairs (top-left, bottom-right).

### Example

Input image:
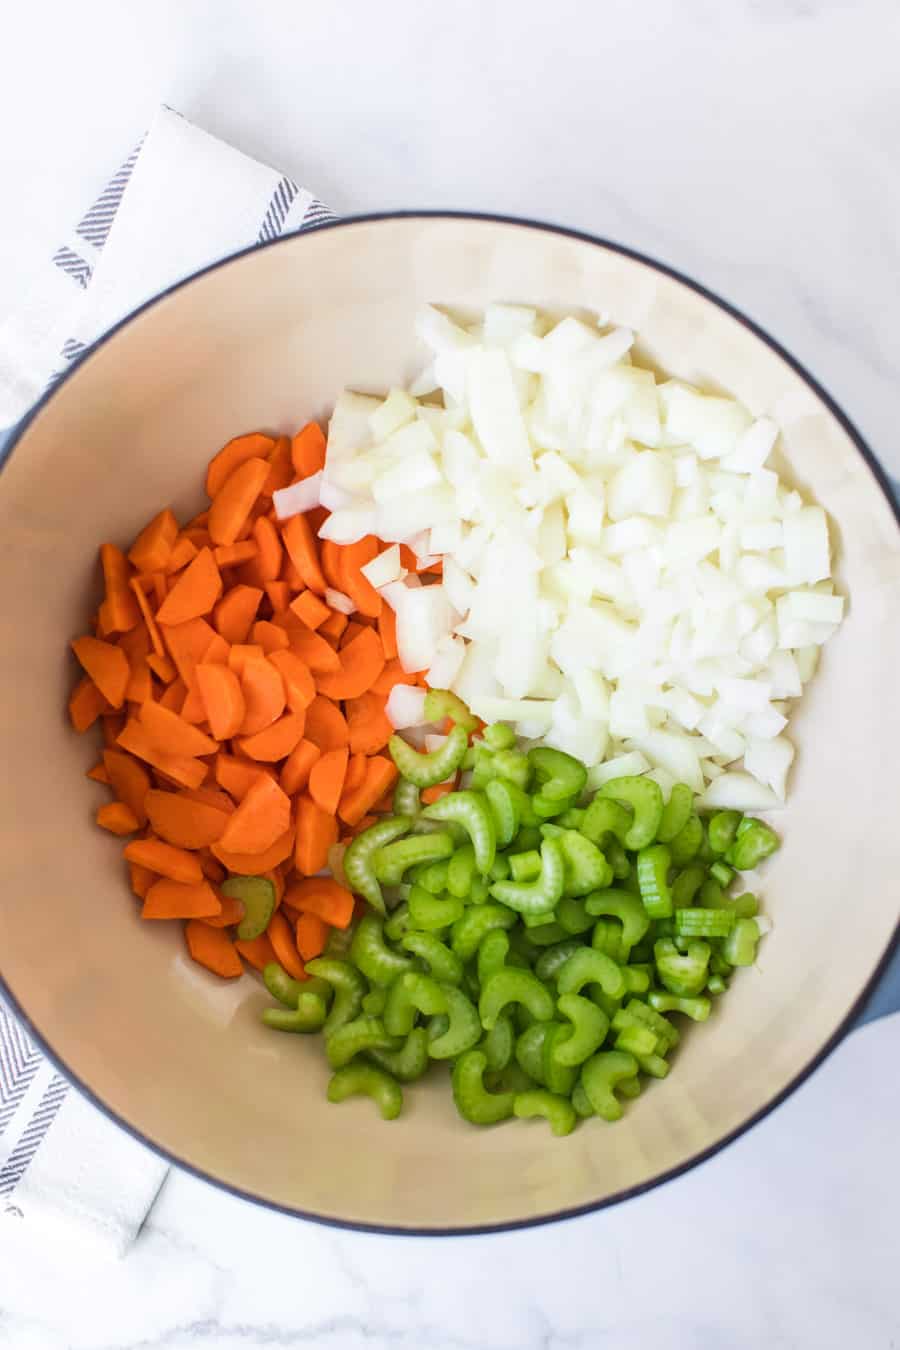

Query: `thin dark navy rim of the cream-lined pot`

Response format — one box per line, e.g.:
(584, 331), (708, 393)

(0, 209), (900, 1238)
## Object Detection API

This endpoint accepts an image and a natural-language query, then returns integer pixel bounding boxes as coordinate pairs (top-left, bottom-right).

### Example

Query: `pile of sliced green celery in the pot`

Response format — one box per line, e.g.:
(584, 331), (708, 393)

(263, 690), (779, 1134)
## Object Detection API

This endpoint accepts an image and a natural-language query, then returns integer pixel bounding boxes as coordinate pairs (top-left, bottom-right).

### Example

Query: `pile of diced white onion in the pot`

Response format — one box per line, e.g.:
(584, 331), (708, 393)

(320, 305), (843, 810)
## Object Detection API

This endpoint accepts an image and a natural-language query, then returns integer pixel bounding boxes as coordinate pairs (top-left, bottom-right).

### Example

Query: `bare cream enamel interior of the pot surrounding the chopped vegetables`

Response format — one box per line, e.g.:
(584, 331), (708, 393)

(0, 215), (900, 1233)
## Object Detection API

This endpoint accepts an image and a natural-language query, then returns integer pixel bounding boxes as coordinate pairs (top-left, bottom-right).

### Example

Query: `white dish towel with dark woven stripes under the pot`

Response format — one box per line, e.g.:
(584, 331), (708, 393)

(0, 108), (332, 1253)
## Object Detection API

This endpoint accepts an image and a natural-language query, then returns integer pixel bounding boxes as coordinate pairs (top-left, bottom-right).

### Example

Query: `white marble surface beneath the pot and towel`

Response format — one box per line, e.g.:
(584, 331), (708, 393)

(0, 0), (900, 1350)
